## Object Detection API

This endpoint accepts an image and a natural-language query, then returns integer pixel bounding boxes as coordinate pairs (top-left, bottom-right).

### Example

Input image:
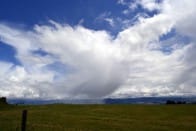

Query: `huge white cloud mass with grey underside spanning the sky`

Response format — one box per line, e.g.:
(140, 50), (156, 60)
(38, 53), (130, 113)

(0, 0), (196, 99)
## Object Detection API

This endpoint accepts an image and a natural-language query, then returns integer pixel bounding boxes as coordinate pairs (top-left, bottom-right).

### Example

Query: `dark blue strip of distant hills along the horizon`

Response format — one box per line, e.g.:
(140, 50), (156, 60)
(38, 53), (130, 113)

(7, 97), (196, 105)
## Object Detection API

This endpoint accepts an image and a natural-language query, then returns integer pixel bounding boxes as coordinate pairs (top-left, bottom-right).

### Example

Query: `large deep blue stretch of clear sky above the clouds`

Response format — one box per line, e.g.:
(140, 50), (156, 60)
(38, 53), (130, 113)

(0, 0), (124, 28)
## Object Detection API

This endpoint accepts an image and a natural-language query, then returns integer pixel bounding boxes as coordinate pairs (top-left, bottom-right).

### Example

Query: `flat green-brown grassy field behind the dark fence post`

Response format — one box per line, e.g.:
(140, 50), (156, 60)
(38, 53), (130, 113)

(0, 104), (196, 131)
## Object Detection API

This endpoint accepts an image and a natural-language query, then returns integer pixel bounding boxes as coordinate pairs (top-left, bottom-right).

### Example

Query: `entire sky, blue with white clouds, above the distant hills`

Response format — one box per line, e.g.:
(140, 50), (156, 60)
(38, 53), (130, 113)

(0, 0), (196, 99)
